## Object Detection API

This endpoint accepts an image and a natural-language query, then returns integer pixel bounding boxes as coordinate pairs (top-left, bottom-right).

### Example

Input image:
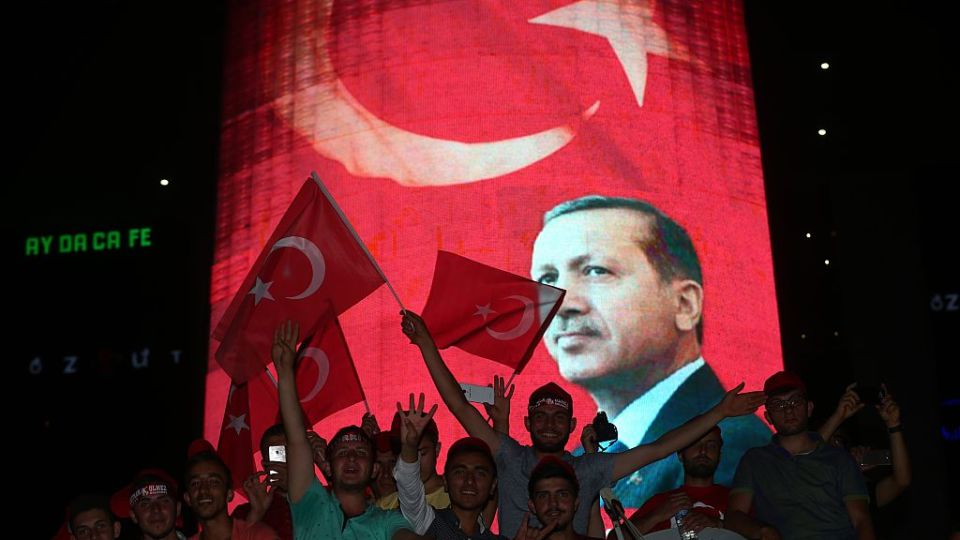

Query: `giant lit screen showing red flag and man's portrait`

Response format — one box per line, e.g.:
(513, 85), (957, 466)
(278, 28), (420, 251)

(205, 0), (782, 506)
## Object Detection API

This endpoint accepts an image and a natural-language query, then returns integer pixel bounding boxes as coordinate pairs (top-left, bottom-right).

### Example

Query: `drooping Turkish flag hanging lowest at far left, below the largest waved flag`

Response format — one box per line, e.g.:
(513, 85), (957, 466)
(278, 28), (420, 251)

(217, 384), (256, 490)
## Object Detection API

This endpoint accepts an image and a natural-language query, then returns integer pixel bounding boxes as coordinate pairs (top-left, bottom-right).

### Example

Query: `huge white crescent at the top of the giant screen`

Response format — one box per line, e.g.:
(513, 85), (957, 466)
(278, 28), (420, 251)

(275, 1), (600, 186)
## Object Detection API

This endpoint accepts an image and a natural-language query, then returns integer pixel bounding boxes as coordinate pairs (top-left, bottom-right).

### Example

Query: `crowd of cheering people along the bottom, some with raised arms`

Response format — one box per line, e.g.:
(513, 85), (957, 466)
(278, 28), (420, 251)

(67, 311), (910, 540)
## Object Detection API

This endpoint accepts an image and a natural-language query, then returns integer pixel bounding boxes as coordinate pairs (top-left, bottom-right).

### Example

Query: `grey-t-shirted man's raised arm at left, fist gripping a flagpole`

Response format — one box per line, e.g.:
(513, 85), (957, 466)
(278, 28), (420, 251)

(401, 311), (500, 454)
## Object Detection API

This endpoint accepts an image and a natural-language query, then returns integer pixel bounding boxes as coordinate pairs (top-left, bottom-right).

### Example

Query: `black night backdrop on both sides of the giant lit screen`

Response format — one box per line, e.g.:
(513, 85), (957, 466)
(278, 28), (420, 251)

(0, 0), (960, 536)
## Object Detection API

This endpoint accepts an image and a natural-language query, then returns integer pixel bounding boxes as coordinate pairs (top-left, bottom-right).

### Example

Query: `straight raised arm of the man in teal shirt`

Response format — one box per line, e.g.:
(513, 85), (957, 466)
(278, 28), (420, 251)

(271, 321), (314, 502)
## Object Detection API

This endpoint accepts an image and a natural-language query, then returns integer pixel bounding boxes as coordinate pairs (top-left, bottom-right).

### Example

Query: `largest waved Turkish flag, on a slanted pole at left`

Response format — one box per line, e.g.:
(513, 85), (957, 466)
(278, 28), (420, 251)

(213, 174), (386, 383)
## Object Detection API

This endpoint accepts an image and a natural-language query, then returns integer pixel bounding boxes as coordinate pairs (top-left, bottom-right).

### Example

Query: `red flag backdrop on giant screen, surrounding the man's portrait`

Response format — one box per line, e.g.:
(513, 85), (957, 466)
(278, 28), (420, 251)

(205, 0), (781, 480)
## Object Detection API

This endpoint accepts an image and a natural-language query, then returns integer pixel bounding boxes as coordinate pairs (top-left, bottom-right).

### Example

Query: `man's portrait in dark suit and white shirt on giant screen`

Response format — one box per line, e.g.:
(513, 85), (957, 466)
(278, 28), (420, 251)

(531, 196), (770, 507)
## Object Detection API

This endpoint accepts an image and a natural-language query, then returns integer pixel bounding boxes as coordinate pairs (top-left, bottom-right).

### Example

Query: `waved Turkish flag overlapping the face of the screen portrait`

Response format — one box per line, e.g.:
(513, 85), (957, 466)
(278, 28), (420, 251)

(422, 251), (565, 373)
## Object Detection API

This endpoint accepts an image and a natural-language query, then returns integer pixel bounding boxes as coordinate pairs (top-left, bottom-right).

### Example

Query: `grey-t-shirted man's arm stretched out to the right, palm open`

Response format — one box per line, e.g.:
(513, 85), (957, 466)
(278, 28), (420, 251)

(613, 383), (766, 480)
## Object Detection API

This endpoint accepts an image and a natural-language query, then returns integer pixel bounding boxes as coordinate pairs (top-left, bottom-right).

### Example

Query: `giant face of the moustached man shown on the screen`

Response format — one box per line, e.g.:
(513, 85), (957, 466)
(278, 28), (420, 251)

(531, 208), (678, 382)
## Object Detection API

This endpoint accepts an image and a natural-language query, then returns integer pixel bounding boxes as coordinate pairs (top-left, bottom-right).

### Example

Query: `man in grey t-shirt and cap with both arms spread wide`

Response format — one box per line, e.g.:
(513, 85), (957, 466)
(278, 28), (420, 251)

(401, 311), (764, 537)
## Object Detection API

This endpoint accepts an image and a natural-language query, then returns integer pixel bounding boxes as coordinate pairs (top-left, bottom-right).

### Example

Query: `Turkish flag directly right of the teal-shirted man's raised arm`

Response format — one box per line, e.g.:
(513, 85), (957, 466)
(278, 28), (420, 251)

(297, 311), (366, 426)
